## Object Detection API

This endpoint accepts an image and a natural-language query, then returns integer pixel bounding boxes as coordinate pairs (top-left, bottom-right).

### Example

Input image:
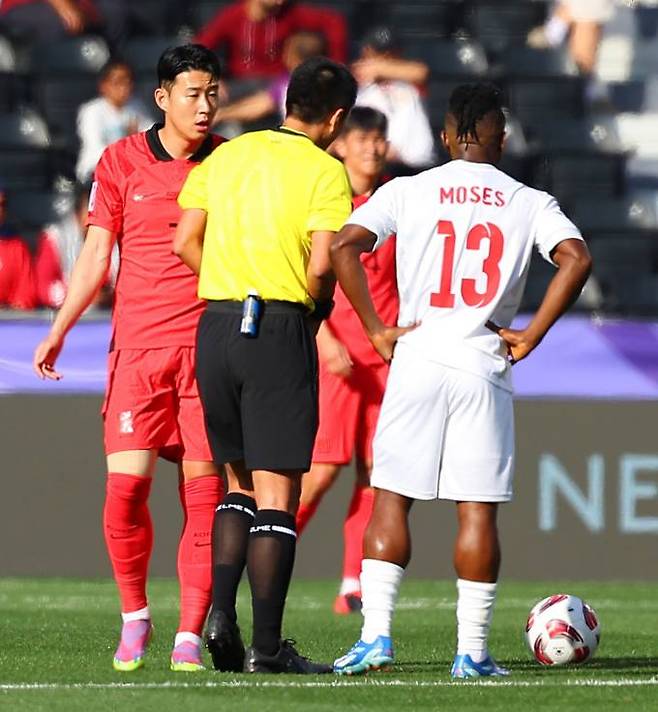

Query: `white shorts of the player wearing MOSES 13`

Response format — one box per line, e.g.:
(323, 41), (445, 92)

(371, 344), (514, 502)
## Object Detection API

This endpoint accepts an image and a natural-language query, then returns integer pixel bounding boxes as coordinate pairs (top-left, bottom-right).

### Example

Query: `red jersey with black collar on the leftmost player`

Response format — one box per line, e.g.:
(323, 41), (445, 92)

(87, 124), (224, 349)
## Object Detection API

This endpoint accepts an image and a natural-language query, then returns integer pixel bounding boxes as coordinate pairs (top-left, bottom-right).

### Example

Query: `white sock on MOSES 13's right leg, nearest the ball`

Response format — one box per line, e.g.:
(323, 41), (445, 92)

(457, 579), (496, 663)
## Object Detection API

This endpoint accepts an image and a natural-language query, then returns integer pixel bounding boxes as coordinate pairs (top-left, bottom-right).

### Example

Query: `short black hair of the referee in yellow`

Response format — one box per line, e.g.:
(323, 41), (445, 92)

(286, 57), (356, 124)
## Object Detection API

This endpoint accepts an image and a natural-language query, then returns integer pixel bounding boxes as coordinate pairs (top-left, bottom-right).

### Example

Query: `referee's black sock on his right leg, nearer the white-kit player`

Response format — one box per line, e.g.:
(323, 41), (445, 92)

(247, 509), (297, 655)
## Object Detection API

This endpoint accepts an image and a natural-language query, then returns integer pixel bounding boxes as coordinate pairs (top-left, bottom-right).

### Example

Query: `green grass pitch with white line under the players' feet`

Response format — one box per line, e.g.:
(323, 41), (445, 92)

(0, 579), (658, 712)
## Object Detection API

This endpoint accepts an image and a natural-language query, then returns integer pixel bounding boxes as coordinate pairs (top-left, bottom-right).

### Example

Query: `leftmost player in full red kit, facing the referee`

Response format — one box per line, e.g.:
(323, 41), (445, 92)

(34, 45), (222, 671)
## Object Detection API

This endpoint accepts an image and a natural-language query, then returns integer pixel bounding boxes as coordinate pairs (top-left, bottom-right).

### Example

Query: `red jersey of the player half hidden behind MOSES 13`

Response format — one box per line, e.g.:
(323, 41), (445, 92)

(329, 195), (399, 365)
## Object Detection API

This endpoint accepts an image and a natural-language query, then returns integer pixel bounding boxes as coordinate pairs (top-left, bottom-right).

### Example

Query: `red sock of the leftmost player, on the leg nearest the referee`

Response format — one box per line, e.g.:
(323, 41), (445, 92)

(178, 475), (224, 635)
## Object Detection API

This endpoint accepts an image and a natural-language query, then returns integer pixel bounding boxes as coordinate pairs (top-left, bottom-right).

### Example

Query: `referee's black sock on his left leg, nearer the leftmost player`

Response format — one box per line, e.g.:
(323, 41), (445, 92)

(212, 492), (256, 623)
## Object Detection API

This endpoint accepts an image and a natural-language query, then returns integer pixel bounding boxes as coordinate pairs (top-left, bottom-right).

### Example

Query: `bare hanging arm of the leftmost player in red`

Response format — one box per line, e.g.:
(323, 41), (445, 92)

(33, 225), (116, 381)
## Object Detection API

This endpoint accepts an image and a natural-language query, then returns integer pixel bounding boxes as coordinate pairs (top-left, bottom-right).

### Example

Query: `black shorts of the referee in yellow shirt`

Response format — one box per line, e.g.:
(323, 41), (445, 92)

(196, 301), (318, 470)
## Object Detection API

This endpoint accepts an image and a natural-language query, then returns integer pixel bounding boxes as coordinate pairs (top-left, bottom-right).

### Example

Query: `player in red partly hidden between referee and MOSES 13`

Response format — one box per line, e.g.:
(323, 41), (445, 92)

(297, 106), (398, 613)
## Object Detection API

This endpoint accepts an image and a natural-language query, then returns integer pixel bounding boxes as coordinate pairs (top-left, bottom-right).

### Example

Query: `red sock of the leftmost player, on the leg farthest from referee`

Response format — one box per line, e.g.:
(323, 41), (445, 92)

(103, 472), (153, 613)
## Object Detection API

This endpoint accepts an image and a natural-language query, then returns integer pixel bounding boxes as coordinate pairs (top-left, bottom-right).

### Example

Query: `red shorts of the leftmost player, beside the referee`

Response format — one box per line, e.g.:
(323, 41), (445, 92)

(102, 346), (212, 462)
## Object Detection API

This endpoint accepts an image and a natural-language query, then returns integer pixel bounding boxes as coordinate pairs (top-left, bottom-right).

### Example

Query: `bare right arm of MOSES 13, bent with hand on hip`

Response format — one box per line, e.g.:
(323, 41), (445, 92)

(496, 240), (592, 363)
